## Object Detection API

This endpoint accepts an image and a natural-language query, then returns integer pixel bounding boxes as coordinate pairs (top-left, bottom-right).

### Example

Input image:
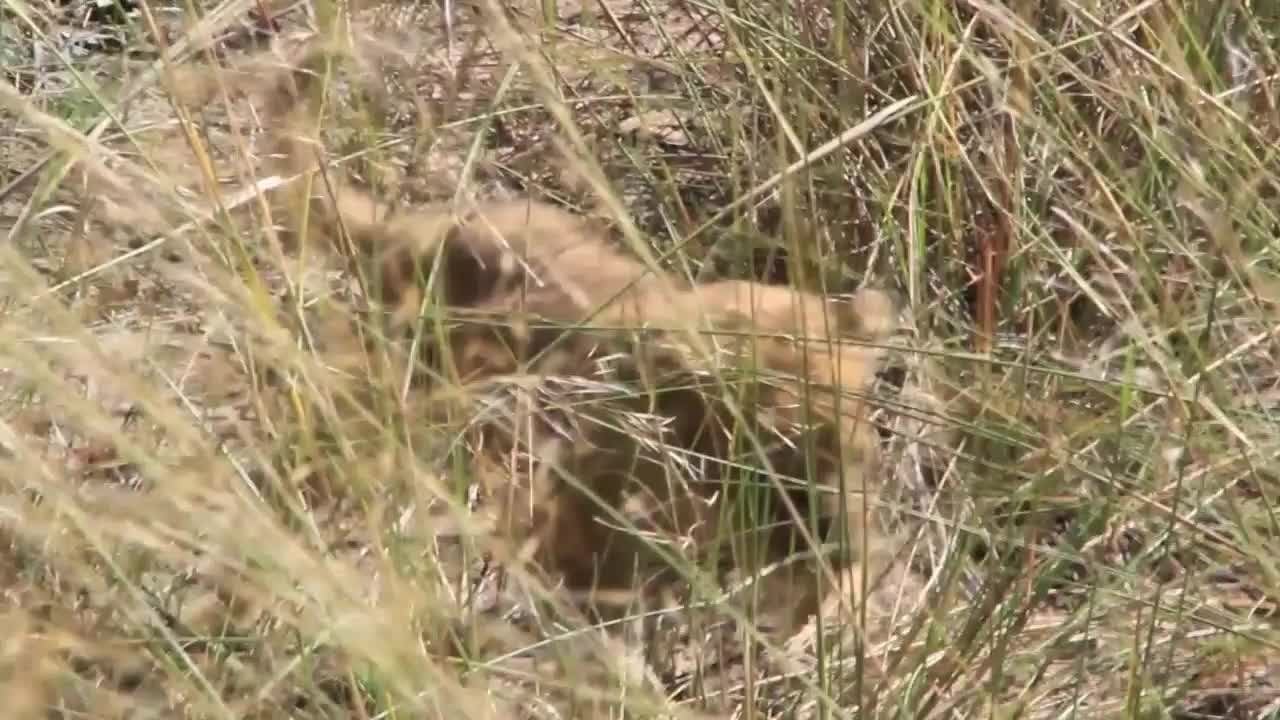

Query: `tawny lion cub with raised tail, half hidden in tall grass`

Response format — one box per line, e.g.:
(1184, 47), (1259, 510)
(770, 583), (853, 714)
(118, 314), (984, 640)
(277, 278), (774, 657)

(249, 43), (897, 625)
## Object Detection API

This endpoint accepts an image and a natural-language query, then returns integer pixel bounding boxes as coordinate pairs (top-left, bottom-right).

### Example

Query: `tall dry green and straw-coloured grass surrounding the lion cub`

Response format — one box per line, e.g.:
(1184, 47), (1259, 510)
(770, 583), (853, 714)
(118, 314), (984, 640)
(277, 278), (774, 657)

(0, 0), (1280, 717)
